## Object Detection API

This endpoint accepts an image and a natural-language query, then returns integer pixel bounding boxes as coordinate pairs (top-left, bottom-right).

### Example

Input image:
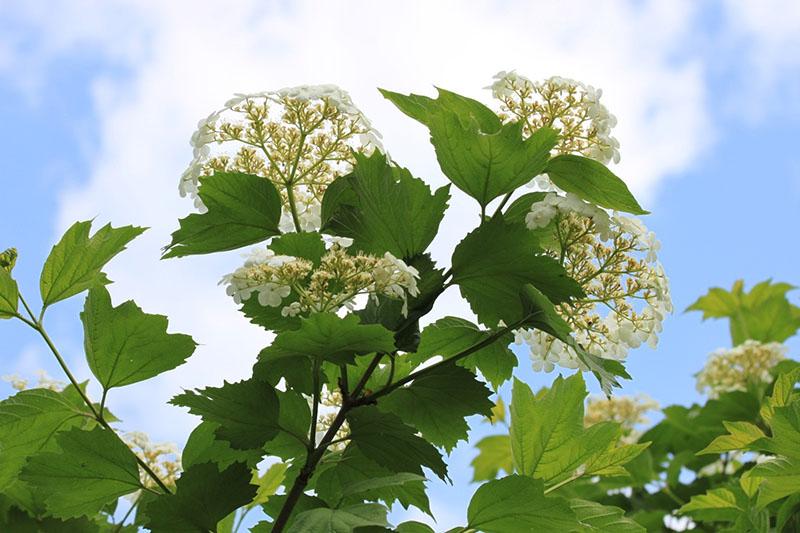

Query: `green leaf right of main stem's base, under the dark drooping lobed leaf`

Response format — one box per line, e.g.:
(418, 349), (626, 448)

(315, 446), (431, 515)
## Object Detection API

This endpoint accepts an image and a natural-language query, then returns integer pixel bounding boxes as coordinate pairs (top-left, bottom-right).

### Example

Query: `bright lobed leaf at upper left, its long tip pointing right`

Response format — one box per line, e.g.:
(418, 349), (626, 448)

(39, 221), (145, 307)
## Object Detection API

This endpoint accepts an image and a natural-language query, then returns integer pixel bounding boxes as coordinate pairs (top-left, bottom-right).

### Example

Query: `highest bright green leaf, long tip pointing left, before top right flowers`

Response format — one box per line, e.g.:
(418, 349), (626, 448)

(383, 89), (557, 207)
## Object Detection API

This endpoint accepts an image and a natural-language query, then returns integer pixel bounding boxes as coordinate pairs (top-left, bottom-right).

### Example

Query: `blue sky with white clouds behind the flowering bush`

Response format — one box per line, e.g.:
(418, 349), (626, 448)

(0, 1), (800, 527)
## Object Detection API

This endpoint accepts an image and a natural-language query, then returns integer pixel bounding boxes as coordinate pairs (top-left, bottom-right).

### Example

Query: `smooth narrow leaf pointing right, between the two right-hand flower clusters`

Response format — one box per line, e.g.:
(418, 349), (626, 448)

(545, 154), (647, 215)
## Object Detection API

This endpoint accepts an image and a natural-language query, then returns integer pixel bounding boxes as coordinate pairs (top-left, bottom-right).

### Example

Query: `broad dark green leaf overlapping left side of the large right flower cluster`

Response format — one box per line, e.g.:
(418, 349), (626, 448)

(453, 218), (583, 327)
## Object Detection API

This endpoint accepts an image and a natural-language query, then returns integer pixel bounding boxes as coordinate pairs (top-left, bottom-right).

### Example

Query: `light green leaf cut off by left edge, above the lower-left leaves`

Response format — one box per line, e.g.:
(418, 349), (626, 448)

(0, 387), (89, 490)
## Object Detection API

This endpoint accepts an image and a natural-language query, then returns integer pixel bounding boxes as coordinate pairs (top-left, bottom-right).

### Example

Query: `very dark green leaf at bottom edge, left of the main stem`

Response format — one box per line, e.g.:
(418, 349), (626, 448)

(142, 463), (257, 533)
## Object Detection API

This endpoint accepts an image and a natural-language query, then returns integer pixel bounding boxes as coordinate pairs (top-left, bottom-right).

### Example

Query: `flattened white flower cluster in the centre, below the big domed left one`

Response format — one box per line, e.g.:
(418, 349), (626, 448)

(221, 238), (419, 316)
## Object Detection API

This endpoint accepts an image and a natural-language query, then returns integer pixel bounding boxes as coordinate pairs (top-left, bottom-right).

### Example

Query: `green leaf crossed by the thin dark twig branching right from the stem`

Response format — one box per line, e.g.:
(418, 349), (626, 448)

(410, 317), (517, 389)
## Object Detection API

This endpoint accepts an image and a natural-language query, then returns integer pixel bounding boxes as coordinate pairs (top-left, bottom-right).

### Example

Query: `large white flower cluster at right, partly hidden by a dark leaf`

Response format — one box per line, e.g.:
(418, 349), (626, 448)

(515, 194), (672, 372)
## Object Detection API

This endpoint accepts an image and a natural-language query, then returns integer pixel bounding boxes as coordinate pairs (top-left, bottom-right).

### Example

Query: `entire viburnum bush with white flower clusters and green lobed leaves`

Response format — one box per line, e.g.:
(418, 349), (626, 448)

(0, 72), (800, 533)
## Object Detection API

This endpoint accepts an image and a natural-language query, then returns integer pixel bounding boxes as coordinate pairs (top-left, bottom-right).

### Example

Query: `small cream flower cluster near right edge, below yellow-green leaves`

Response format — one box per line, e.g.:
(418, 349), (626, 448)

(697, 340), (786, 398)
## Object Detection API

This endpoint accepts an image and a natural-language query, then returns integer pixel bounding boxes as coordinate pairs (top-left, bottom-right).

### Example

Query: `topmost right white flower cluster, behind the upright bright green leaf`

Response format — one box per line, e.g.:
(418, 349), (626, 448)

(489, 71), (619, 164)
